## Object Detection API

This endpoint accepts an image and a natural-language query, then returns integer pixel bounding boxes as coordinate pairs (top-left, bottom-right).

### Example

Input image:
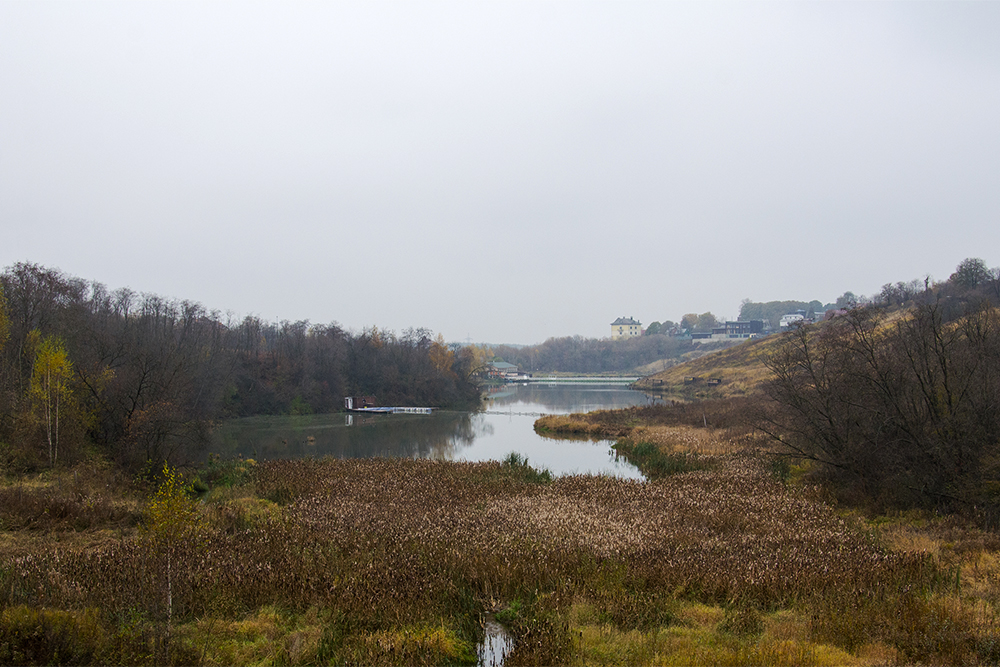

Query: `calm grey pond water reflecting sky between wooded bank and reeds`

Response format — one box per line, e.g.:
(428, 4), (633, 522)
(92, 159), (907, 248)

(210, 383), (655, 479)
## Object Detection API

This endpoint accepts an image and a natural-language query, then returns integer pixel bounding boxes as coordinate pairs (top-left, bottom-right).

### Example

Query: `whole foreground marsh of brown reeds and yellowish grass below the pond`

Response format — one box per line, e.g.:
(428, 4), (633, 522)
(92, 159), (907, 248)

(0, 424), (1000, 665)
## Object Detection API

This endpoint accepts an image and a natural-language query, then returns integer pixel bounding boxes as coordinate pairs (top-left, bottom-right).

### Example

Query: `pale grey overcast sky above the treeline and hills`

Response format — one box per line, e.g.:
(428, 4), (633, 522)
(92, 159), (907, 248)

(0, 0), (1000, 343)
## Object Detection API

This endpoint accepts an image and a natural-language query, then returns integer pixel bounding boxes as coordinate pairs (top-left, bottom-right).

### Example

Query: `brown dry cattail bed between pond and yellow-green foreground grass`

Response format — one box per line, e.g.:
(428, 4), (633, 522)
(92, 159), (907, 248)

(2, 456), (960, 663)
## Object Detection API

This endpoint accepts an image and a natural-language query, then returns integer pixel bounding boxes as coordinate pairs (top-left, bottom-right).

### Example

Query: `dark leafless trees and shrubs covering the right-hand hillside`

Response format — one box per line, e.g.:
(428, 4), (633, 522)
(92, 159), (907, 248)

(760, 260), (1000, 521)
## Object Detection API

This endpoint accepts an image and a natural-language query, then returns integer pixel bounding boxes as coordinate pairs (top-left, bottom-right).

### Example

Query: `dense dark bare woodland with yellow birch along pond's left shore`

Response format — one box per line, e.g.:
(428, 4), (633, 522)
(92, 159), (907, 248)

(0, 263), (478, 467)
